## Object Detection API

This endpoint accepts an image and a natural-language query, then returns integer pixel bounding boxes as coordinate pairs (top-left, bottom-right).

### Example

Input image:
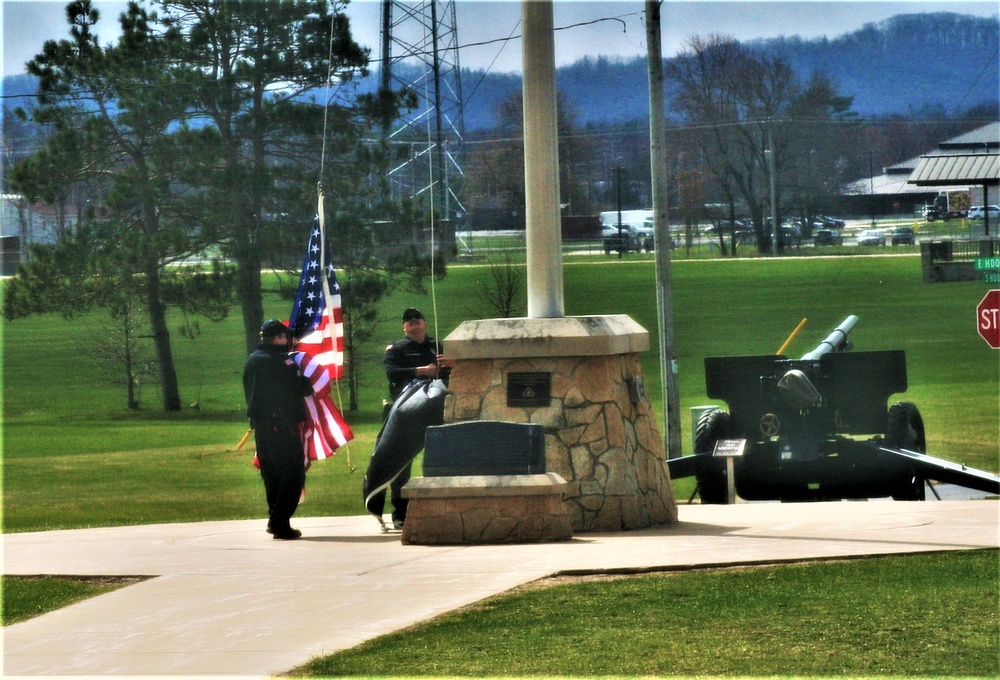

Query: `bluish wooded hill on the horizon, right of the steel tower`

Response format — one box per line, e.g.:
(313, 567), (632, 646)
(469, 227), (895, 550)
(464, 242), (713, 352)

(462, 12), (1000, 130)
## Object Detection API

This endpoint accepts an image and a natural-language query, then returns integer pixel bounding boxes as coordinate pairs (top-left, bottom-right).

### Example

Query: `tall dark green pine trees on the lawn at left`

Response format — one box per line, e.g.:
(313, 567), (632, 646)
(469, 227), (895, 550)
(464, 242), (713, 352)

(4, 0), (428, 411)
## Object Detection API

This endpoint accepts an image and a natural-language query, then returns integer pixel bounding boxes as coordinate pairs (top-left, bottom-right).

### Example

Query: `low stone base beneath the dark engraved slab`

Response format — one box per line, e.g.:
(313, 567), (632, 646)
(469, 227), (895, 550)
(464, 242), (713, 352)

(402, 472), (573, 545)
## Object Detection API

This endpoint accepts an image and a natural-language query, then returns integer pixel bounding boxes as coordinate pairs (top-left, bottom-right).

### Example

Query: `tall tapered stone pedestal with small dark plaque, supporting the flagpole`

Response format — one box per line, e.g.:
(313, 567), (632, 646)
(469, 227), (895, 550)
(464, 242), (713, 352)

(444, 315), (677, 531)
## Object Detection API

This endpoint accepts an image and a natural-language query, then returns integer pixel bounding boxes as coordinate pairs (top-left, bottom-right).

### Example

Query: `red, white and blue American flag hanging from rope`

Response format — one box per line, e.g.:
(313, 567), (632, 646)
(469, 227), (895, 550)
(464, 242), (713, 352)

(289, 218), (354, 460)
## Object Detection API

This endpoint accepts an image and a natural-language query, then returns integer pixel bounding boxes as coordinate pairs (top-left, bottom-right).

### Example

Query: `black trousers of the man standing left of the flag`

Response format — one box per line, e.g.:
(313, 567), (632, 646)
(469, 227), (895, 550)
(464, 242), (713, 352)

(254, 423), (306, 532)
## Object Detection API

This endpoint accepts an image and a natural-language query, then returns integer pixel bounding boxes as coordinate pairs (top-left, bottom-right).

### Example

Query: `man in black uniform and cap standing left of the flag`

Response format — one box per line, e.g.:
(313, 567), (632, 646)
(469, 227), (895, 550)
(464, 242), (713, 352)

(243, 319), (312, 540)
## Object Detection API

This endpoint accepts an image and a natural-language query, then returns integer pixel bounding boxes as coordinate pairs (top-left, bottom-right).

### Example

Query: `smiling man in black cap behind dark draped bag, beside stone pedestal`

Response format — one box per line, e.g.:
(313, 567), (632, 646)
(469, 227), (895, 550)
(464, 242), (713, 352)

(382, 307), (451, 529)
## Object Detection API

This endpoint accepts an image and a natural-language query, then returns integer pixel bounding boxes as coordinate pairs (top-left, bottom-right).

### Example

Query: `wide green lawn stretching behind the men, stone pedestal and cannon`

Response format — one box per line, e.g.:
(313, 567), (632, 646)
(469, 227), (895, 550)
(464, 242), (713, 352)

(3, 250), (1000, 531)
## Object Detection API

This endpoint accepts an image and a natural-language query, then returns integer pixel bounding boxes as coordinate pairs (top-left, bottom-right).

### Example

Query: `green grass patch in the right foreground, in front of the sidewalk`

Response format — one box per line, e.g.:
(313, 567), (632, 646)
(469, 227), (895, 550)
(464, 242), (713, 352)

(292, 550), (1000, 678)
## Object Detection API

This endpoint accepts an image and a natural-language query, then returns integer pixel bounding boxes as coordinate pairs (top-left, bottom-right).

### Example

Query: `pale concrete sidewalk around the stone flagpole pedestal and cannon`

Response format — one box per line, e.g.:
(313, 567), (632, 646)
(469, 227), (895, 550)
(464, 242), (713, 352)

(3, 501), (1000, 677)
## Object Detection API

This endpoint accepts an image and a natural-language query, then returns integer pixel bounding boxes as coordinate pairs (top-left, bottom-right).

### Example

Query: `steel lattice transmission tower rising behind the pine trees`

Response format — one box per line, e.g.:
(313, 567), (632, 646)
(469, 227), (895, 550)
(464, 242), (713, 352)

(380, 0), (467, 243)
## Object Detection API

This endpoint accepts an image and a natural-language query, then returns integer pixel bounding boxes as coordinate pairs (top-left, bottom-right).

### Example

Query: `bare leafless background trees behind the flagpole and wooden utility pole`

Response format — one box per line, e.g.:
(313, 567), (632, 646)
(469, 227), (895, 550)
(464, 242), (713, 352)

(467, 36), (855, 252)
